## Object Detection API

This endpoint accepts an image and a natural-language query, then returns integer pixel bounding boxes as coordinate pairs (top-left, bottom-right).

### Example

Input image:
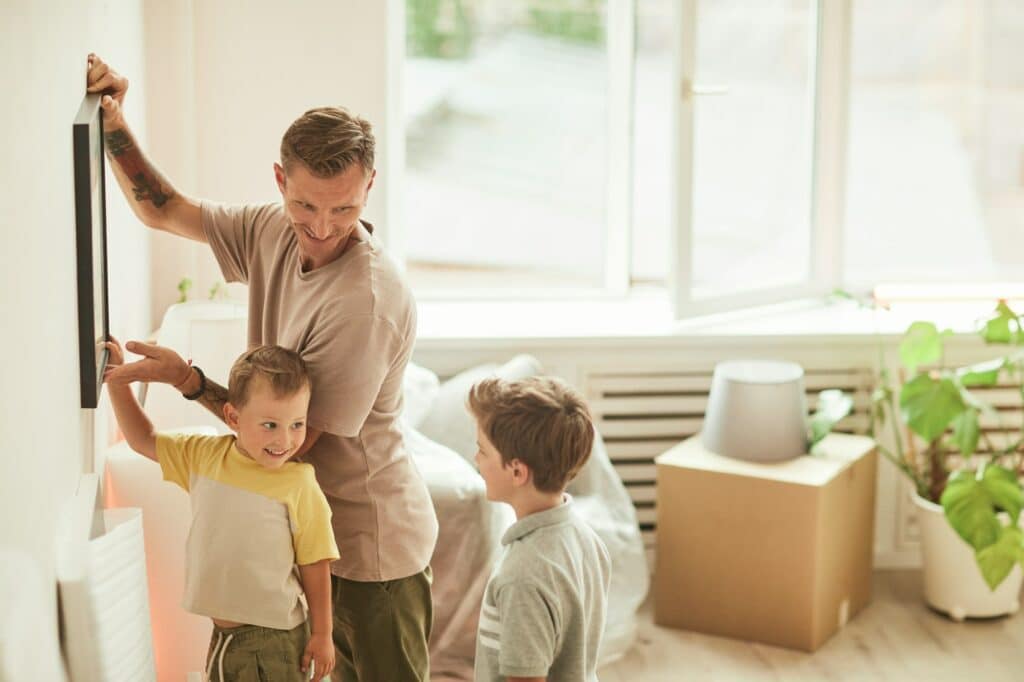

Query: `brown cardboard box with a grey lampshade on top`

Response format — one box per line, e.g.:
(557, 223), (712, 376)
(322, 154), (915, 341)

(654, 434), (877, 651)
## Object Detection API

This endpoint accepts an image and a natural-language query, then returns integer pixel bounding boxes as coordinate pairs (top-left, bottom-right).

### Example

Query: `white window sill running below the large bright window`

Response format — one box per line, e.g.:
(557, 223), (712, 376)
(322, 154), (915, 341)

(418, 296), (994, 348)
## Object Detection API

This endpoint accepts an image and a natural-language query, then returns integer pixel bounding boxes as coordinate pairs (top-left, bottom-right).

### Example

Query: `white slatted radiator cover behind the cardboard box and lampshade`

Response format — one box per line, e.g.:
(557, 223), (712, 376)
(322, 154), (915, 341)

(583, 365), (872, 566)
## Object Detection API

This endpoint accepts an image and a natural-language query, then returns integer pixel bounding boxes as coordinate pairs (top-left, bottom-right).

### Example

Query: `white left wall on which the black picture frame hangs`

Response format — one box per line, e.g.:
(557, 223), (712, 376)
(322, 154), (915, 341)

(0, 0), (150, 667)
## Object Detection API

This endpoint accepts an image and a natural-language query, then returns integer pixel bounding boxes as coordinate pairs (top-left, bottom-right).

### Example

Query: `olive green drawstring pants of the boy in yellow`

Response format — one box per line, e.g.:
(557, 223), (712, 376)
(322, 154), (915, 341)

(206, 623), (309, 682)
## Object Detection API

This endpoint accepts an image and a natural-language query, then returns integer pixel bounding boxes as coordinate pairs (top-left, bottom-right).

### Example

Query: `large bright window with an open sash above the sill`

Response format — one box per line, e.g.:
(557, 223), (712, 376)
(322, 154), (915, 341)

(395, 0), (1024, 316)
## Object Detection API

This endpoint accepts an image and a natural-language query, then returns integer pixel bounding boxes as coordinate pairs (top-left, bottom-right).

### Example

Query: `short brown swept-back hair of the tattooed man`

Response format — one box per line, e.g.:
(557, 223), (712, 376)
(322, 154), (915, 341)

(281, 106), (376, 177)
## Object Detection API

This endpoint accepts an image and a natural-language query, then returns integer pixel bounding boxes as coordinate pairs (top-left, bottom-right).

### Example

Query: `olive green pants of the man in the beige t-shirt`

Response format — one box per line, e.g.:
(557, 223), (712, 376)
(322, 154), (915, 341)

(331, 566), (433, 682)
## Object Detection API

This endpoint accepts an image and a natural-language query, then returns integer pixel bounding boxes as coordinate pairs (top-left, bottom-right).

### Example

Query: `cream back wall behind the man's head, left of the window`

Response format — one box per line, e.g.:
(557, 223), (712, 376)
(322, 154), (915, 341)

(146, 0), (402, 326)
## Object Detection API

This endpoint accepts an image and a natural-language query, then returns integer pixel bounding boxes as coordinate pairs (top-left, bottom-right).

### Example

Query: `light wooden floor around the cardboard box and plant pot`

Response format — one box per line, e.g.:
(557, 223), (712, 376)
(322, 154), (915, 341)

(599, 570), (1024, 682)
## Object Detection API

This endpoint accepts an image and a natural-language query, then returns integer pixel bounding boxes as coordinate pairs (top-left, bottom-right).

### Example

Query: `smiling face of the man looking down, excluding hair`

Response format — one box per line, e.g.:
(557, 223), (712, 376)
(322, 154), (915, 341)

(273, 163), (377, 271)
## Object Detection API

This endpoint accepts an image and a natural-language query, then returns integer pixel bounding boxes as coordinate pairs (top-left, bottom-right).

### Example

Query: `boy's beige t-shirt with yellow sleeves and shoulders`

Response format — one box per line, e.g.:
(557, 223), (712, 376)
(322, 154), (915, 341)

(157, 434), (338, 630)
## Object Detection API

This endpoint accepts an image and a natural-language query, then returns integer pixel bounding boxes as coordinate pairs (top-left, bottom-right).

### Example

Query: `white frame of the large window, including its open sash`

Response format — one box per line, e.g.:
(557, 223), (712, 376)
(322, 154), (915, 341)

(385, 0), (852, 319)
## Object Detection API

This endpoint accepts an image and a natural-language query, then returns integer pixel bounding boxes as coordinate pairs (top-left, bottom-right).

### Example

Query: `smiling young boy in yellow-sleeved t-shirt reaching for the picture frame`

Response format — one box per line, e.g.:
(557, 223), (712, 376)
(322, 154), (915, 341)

(106, 339), (338, 682)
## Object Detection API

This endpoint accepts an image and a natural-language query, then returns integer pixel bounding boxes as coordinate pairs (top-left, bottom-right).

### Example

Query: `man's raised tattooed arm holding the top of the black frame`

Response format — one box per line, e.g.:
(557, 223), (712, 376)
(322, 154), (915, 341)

(86, 54), (207, 242)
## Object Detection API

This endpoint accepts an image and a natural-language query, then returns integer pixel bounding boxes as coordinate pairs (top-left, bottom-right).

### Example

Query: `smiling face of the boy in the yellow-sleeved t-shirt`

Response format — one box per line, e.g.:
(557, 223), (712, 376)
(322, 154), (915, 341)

(224, 377), (309, 469)
